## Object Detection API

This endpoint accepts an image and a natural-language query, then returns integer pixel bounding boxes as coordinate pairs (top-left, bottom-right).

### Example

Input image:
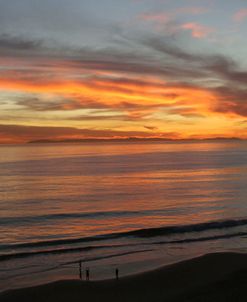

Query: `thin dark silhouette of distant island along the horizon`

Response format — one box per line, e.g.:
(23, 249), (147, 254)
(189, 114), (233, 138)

(28, 137), (243, 144)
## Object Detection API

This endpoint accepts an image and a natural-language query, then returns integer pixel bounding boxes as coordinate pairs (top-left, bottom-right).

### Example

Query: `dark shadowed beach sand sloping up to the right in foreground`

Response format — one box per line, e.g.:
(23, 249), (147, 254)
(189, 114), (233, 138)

(0, 253), (247, 302)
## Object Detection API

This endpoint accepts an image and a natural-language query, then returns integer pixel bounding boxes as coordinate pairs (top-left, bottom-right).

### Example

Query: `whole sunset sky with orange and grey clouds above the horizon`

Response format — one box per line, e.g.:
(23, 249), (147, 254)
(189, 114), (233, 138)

(0, 0), (247, 143)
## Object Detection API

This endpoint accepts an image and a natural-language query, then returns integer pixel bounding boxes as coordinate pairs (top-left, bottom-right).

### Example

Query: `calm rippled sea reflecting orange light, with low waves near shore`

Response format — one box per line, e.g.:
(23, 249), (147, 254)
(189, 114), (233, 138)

(0, 142), (247, 290)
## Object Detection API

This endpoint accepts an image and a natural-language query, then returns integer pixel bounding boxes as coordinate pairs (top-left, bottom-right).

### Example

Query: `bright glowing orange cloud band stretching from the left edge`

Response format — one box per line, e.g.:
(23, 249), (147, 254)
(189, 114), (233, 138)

(0, 72), (213, 116)
